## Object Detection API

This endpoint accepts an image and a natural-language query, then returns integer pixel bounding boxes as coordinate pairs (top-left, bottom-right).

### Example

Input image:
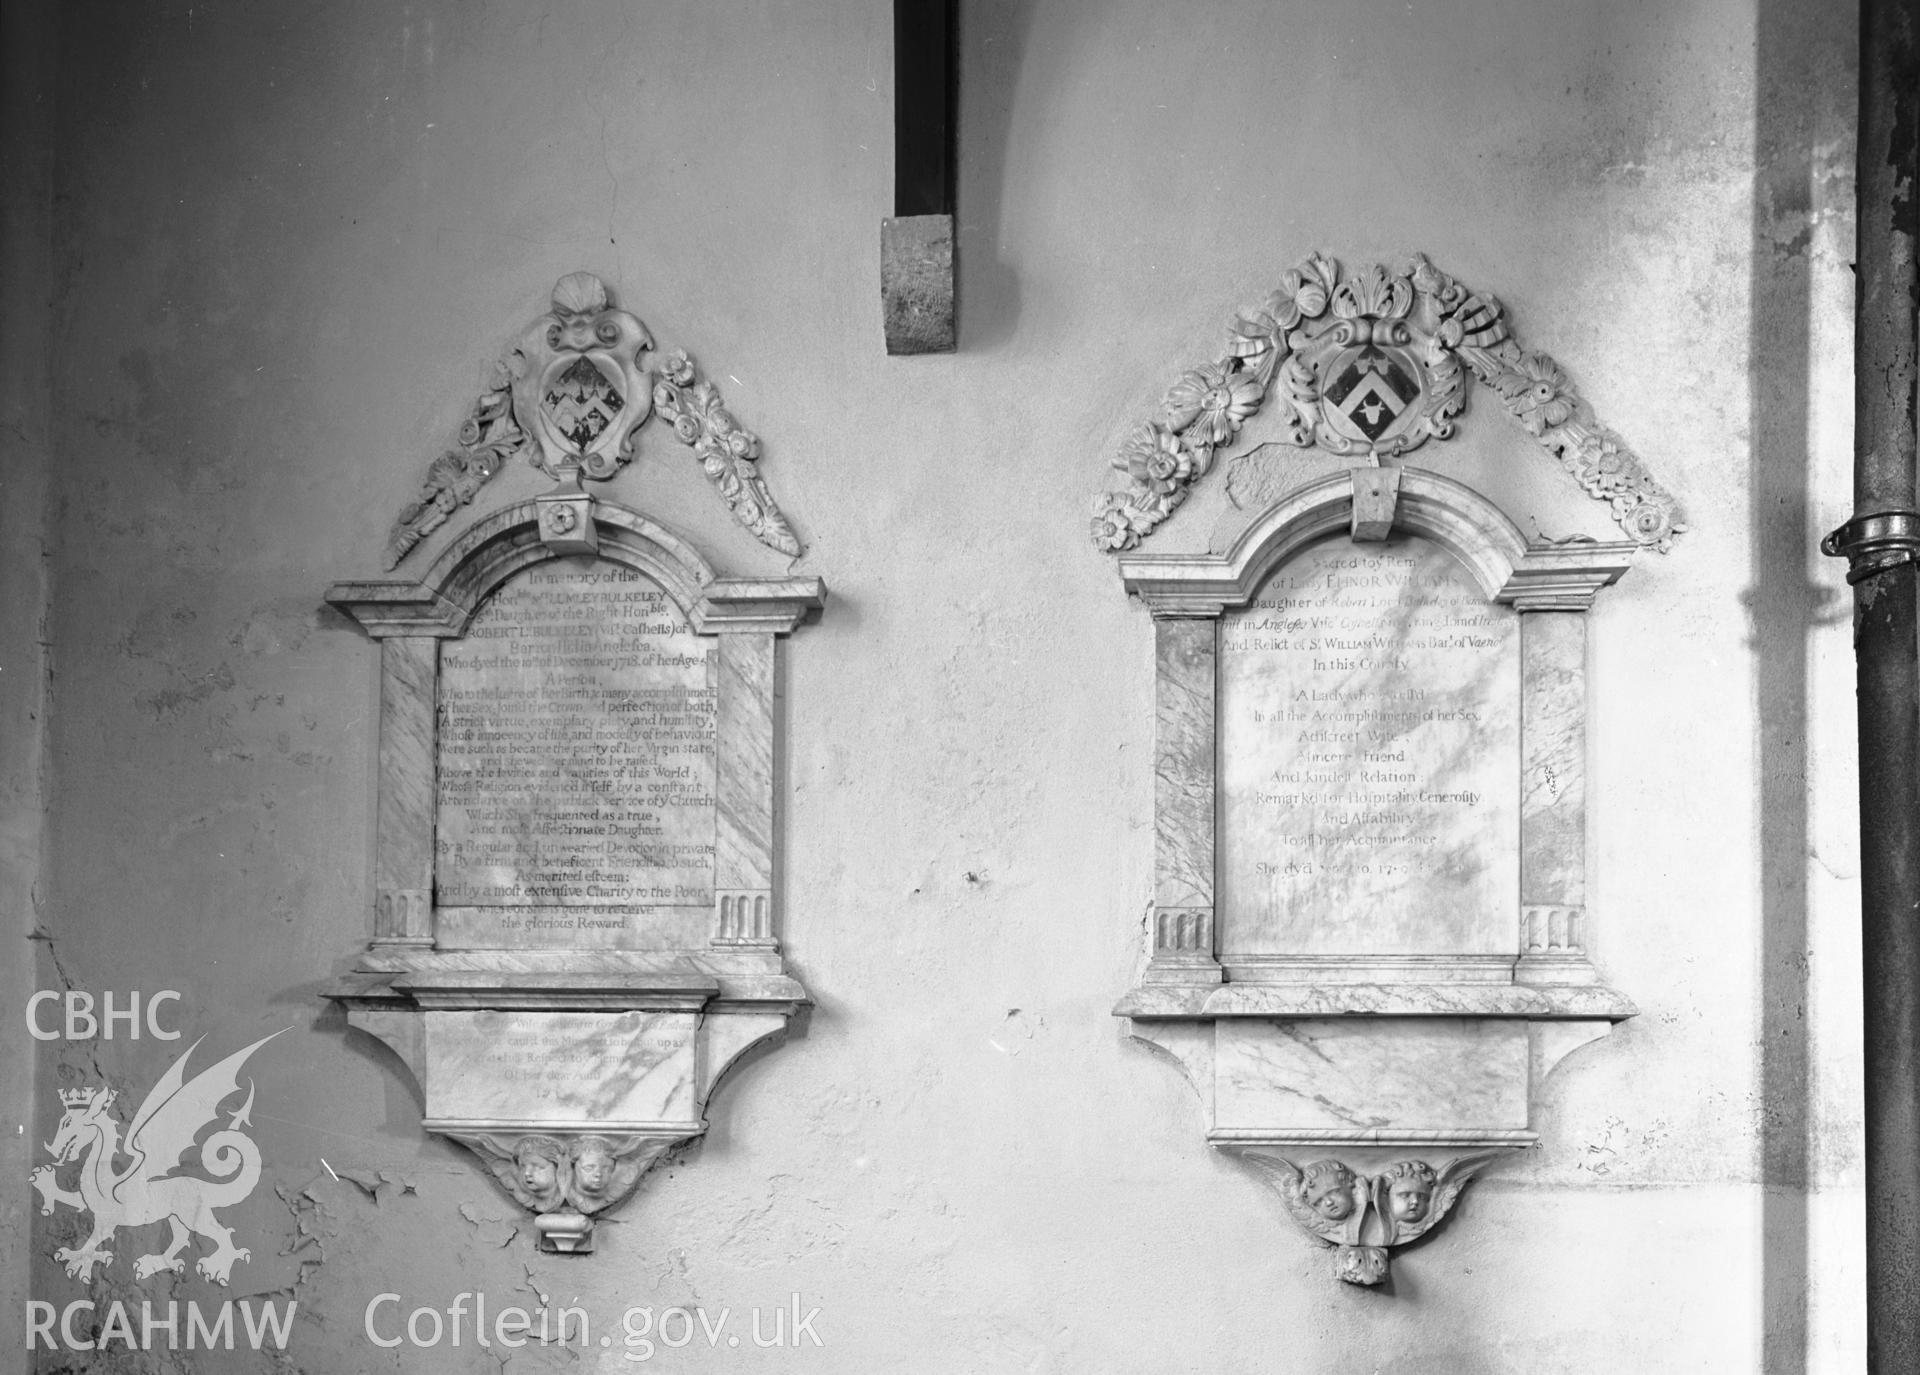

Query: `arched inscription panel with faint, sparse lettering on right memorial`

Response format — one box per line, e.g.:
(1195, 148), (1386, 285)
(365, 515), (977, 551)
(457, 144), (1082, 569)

(1219, 540), (1521, 962)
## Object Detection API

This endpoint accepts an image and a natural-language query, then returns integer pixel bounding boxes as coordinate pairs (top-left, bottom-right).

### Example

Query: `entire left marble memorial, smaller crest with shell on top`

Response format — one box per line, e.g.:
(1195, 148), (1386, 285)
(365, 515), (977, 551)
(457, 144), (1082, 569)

(326, 273), (826, 1252)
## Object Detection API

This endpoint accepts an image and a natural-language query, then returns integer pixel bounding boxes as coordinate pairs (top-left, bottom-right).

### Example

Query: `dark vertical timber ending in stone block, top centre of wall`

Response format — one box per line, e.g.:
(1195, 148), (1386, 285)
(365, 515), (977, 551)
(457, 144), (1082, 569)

(879, 0), (960, 353)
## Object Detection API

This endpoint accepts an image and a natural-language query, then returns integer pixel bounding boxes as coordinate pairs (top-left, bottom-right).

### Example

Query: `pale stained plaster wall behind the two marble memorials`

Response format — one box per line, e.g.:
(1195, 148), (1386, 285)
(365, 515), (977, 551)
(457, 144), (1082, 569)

(11, 0), (1860, 1375)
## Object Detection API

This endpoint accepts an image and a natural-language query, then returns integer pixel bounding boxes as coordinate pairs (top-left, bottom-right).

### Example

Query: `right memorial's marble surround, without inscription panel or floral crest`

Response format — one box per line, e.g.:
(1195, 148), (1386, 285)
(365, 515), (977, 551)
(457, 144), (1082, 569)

(1114, 467), (1638, 1285)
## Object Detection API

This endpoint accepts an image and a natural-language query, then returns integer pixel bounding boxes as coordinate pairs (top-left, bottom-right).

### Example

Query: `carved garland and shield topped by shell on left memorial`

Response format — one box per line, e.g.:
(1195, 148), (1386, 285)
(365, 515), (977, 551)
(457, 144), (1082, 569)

(386, 273), (801, 568)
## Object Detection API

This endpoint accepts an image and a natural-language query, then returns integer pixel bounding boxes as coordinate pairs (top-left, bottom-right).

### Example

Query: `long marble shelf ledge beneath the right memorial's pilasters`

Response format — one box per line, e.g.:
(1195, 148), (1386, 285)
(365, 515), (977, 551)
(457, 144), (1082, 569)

(1114, 983), (1638, 1022)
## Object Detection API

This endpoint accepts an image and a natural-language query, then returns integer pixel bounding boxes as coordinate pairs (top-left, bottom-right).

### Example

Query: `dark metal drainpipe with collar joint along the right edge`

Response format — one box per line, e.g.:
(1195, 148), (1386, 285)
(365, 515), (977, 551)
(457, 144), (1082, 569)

(1820, 0), (1920, 1375)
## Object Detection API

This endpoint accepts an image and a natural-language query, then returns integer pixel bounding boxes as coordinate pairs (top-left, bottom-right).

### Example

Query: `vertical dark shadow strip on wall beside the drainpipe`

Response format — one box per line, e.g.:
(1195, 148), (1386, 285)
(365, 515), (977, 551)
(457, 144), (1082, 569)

(1747, 0), (1853, 1375)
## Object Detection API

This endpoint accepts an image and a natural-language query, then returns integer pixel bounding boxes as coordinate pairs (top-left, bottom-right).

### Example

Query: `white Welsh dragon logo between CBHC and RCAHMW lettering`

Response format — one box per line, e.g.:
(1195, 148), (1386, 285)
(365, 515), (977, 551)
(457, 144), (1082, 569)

(31, 1031), (280, 1285)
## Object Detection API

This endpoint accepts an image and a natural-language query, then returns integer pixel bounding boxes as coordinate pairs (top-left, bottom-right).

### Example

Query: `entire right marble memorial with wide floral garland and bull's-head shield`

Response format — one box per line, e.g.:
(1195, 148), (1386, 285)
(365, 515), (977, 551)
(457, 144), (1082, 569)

(1092, 257), (1684, 1285)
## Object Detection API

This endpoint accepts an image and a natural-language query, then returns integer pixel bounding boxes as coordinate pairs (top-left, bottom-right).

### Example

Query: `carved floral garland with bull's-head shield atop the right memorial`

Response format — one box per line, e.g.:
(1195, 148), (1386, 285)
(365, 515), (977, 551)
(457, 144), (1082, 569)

(1092, 253), (1686, 553)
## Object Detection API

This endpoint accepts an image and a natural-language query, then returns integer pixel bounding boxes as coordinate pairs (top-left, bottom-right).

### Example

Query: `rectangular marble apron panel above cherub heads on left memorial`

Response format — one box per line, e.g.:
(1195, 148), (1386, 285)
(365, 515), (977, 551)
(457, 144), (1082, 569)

(426, 1012), (697, 1125)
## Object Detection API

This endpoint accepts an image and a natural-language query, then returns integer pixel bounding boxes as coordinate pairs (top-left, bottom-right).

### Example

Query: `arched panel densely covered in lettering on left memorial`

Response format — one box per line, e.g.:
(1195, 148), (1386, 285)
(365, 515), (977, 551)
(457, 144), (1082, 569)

(434, 557), (716, 947)
